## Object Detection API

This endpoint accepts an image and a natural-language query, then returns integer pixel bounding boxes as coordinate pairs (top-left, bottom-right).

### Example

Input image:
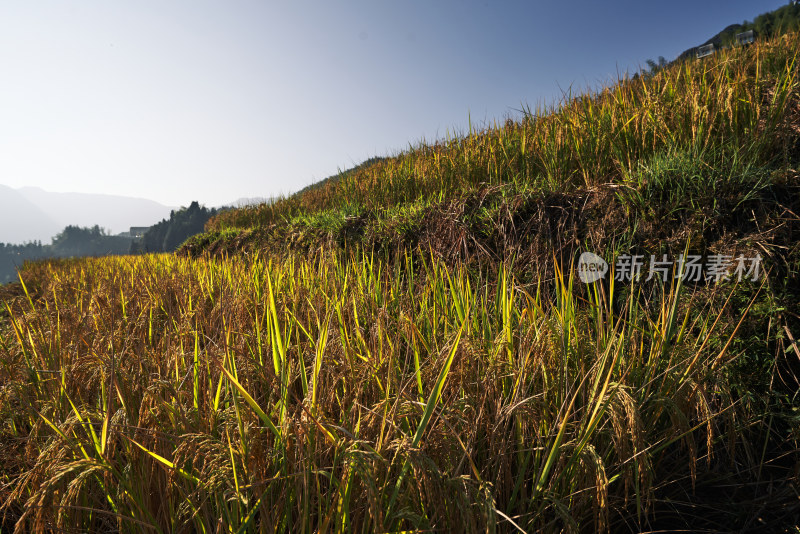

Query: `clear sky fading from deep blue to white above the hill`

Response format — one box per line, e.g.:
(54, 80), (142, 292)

(0, 0), (786, 205)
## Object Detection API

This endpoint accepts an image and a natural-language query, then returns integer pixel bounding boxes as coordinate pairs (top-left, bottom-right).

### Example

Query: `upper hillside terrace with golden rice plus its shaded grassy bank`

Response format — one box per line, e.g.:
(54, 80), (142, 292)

(191, 32), (798, 284)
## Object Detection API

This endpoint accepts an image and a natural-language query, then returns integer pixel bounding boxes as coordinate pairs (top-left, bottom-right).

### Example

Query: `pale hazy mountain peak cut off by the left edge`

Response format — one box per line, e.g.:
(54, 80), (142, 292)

(0, 185), (63, 243)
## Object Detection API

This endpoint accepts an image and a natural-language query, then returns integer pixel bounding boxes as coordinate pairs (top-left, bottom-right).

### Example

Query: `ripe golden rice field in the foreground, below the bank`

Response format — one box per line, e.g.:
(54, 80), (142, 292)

(0, 256), (791, 532)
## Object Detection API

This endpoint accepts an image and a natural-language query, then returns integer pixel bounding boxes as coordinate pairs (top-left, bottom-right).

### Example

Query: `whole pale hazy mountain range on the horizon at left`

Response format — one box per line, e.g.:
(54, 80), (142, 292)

(0, 186), (173, 243)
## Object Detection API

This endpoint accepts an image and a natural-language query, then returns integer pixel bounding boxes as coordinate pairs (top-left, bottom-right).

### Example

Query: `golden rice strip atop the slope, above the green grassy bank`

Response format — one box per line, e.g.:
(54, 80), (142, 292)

(209, 34), (800, 230)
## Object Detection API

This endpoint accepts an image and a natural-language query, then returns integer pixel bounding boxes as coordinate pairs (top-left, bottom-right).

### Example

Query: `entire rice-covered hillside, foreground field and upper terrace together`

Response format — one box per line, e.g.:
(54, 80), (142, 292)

(0, 30), (800, 532)
